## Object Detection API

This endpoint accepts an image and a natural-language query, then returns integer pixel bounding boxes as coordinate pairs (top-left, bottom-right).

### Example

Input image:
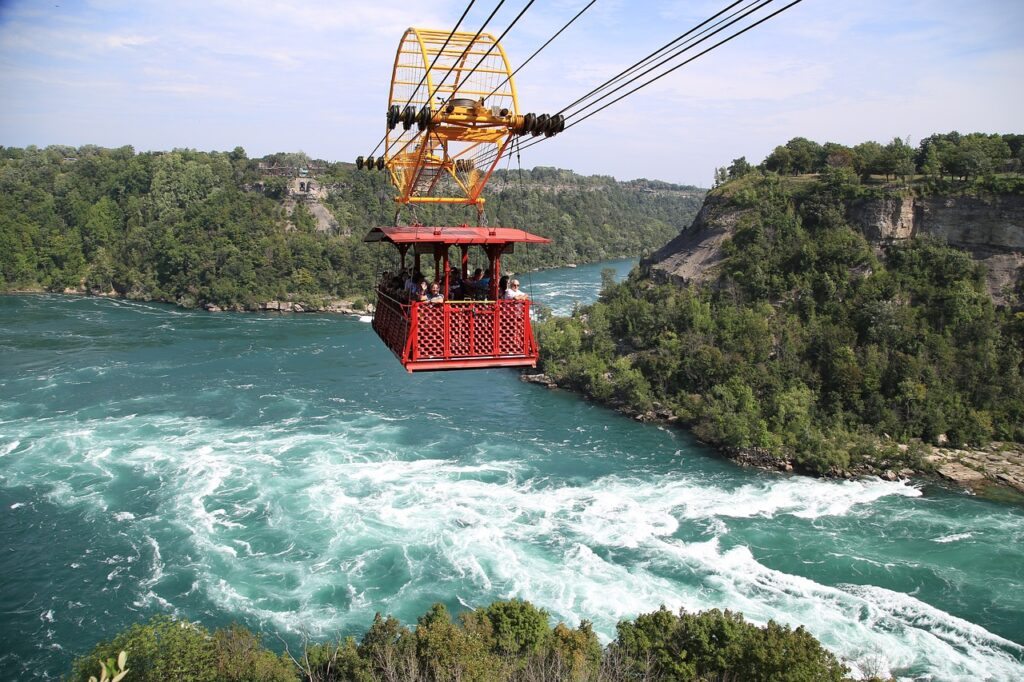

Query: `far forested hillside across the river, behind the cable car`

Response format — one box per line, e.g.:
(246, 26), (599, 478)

(0, 146), (703, 308)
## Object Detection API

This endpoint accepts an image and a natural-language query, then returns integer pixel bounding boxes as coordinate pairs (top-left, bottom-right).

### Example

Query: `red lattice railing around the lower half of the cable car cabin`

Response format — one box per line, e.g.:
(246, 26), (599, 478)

(374, 292), (537, 372)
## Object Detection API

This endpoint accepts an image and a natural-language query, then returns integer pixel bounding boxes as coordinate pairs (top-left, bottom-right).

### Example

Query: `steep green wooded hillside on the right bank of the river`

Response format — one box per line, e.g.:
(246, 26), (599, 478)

(540, 131), (1024, 472)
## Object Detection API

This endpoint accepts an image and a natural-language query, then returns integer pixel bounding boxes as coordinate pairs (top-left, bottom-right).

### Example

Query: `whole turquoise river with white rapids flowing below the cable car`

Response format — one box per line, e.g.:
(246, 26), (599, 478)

(0, 261), (1024, 680)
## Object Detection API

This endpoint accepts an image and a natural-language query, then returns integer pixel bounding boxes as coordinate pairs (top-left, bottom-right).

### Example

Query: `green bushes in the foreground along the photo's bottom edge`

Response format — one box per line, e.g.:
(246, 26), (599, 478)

(72, 601), (848, 682)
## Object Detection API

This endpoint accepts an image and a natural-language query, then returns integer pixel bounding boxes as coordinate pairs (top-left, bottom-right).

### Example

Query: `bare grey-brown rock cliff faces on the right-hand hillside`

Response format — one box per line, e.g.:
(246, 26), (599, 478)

(643, 186), (1024, 305)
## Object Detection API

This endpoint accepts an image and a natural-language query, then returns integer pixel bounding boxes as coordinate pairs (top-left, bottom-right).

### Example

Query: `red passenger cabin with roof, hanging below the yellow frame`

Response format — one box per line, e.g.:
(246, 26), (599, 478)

(364, 225), (551, 372)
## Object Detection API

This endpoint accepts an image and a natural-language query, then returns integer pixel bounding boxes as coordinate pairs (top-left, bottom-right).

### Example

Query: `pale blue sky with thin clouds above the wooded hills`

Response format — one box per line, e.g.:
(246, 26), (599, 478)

(0, 0), (1024, 186)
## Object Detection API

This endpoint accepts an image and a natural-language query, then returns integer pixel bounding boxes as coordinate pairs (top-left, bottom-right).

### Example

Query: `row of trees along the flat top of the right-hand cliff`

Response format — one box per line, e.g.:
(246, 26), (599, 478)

(715, 131), (1024, 191)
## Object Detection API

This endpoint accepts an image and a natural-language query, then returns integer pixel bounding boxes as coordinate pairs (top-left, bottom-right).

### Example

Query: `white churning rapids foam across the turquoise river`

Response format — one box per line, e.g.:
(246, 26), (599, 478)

(6, 405), (1021, 679)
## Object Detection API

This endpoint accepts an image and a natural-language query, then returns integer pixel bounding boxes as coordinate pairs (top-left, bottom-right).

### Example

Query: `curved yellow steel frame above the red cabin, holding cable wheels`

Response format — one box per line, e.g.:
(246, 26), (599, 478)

(384, 28), (521, 210)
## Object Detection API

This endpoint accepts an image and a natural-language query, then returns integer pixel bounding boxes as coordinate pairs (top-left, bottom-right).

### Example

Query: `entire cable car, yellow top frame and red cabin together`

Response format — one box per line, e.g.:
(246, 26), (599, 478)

(356, 29), (564, 372)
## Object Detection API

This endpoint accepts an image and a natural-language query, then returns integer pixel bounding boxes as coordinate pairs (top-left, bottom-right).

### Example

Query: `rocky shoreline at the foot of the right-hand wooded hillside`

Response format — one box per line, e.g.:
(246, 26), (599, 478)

(519, 372), (1024, 503)
